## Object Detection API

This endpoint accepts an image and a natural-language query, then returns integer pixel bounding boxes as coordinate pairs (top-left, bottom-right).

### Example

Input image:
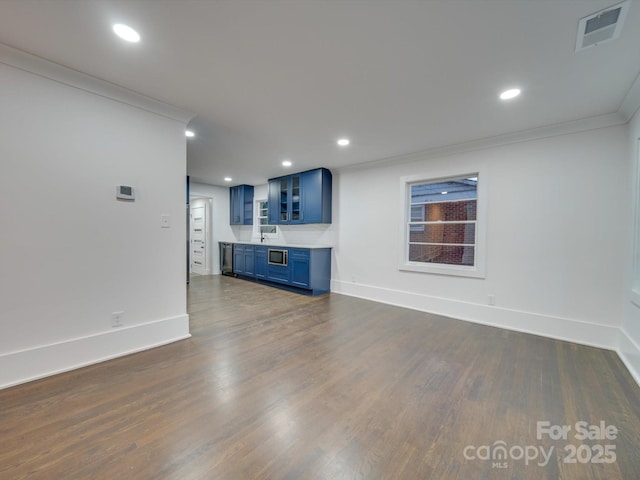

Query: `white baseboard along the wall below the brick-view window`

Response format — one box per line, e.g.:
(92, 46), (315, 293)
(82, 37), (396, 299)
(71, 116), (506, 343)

(331, 280), (620, 348)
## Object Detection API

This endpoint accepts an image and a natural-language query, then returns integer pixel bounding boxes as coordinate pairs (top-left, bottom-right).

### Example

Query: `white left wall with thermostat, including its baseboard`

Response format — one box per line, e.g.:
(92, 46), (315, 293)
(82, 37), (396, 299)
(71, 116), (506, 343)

(0, 52), (189, 387)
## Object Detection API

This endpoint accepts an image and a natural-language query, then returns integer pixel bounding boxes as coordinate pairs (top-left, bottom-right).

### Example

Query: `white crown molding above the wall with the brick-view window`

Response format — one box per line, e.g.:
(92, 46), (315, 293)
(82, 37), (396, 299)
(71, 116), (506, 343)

(335, 111), (624, 171)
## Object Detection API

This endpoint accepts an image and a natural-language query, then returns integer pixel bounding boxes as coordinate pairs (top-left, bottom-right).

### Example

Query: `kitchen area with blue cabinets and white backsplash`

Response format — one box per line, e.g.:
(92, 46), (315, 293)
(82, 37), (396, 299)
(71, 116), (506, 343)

(190, 168), (335, 295)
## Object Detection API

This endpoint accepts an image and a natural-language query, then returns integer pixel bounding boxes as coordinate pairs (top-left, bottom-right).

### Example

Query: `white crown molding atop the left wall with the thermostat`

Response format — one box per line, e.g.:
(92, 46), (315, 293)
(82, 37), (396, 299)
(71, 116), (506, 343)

(0, 44), (195, 125)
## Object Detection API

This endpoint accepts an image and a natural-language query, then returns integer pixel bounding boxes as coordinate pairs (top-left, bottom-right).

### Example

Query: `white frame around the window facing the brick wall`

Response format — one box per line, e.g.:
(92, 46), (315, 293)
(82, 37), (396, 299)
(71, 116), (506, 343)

(398, 168), (488, 278)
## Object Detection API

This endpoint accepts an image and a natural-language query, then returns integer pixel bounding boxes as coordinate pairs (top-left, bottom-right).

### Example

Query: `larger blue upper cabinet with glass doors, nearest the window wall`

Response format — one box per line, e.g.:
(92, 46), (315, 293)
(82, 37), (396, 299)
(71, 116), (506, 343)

(269, 168), (331, 225)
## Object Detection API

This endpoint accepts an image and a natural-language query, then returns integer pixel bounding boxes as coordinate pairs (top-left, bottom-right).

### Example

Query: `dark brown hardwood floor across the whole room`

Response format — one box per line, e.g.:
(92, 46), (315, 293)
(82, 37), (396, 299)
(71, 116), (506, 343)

(0, 276), (640, 480)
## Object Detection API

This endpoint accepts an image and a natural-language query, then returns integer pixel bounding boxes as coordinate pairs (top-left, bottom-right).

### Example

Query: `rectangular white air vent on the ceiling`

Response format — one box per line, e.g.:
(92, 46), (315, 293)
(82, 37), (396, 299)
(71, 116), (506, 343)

(576, 0), (630, 52)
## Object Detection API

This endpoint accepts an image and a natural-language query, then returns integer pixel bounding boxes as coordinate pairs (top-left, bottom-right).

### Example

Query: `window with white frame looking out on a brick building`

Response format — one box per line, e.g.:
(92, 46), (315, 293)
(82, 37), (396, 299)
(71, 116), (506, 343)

(400, 172), (484, 277)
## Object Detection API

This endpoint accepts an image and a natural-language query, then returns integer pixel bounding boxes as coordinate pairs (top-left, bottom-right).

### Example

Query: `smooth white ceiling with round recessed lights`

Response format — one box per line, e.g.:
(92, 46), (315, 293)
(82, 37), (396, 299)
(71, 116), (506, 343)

(0, 0), (640, 185)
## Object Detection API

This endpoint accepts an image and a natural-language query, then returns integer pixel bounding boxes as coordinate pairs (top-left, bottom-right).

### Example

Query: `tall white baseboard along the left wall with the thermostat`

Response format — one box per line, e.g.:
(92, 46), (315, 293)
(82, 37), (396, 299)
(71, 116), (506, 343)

(0, 314), (191, 389)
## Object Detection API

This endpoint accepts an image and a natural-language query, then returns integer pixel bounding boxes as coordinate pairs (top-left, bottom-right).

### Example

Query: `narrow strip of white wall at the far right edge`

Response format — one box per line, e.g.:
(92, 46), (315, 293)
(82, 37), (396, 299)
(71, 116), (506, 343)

(618, 112), (640, 383)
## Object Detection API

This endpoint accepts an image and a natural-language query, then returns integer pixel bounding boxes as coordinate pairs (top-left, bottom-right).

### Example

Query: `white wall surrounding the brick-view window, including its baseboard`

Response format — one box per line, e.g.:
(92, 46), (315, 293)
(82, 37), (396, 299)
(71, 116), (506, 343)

(332, 126), (630, 348)
